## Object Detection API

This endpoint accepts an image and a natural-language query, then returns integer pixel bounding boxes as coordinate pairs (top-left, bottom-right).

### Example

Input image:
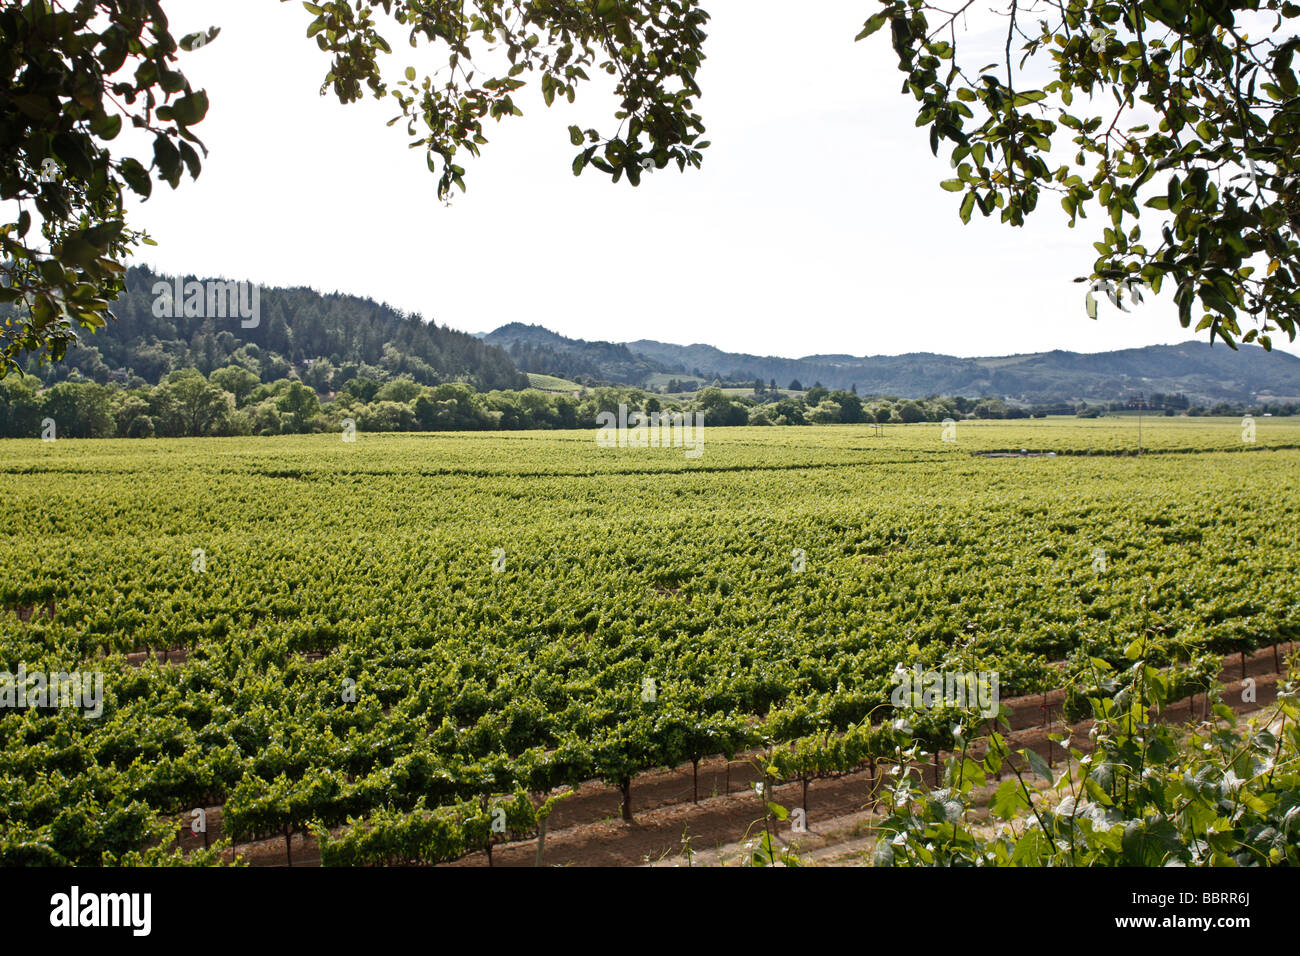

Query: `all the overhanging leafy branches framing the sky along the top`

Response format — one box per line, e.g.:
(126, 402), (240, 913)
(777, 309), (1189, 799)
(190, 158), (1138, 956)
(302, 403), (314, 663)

(0, 0), (1300, 375)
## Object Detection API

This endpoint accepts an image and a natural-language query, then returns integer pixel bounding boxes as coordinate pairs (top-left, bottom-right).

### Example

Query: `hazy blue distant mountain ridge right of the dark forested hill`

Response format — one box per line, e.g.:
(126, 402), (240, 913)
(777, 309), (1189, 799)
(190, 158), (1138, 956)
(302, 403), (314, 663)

(478, 323), (1300, 405)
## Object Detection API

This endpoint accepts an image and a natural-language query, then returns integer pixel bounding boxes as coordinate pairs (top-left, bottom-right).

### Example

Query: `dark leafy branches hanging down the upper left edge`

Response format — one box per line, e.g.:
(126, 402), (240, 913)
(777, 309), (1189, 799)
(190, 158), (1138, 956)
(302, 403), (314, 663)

(0, 0), (217, 375)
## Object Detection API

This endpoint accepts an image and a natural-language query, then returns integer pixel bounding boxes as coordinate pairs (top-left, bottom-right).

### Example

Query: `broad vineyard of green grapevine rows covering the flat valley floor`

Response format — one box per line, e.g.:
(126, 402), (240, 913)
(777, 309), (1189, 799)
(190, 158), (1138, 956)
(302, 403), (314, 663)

(0, 419), (1300, 864)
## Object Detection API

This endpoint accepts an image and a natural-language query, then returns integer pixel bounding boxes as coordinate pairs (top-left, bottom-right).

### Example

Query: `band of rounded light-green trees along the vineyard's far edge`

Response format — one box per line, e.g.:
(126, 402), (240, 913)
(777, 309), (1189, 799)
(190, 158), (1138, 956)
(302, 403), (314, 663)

(0, 365), (1170, 438)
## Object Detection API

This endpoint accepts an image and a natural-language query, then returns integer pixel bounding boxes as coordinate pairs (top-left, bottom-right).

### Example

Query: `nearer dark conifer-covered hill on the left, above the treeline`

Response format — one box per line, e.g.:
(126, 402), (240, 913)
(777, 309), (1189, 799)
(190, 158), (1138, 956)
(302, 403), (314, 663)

(40, 267), (528, 390)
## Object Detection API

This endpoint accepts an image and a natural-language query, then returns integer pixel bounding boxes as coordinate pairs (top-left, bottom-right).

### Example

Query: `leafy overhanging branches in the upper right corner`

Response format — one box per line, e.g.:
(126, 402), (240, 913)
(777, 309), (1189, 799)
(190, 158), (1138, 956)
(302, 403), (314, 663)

(858, 0), (1300, 349)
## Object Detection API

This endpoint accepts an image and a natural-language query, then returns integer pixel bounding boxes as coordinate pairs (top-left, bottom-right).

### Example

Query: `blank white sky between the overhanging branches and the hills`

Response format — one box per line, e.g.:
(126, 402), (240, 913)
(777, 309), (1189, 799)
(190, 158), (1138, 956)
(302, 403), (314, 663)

(119, 0), (1300, 356)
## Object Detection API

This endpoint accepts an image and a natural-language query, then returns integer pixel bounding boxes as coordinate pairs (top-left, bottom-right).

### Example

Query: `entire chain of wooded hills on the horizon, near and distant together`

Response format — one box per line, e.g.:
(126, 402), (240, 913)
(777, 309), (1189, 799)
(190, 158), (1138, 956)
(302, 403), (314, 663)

(29, 267), (1300, 406)
